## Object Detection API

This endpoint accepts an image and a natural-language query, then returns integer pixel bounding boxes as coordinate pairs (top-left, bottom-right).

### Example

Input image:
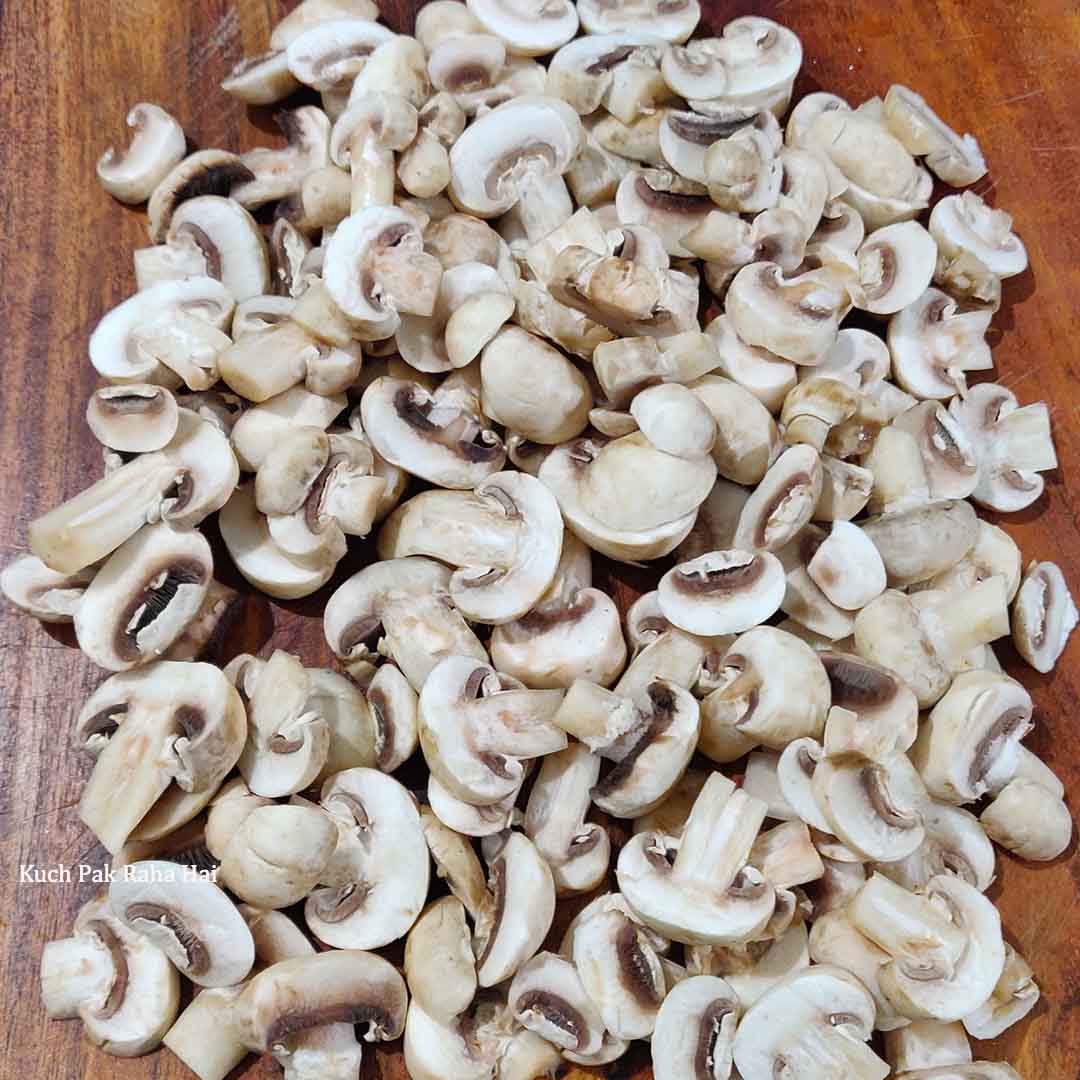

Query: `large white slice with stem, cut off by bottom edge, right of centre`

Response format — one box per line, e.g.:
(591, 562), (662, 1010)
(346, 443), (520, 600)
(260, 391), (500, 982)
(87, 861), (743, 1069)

(734, 964), (889, 1080)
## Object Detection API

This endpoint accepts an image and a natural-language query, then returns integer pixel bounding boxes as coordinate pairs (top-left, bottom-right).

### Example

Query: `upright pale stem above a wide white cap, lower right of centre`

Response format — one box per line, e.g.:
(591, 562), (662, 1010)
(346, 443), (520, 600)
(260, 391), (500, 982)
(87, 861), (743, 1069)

(674, 773), (768, 893)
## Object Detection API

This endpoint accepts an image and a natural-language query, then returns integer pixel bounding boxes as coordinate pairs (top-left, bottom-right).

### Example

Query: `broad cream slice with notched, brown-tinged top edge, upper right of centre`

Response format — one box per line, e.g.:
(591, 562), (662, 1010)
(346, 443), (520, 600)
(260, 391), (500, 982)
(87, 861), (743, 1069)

(726, 262), (851, 365)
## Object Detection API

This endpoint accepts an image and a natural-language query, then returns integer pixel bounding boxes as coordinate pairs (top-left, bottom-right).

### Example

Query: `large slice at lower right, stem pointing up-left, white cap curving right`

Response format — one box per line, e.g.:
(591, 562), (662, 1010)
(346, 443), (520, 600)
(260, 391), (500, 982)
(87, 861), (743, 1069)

(848, 874), (1005, 1023)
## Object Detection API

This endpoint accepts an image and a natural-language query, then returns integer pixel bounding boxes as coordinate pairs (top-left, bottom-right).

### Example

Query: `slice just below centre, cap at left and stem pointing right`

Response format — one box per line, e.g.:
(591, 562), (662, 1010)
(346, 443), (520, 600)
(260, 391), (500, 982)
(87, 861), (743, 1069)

(419, 657), (567, 806)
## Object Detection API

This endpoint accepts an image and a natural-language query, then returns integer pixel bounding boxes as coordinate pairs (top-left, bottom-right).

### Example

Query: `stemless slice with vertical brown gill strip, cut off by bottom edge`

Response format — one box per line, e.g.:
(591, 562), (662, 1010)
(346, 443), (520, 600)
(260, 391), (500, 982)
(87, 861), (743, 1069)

(652, 975), (741, 1080)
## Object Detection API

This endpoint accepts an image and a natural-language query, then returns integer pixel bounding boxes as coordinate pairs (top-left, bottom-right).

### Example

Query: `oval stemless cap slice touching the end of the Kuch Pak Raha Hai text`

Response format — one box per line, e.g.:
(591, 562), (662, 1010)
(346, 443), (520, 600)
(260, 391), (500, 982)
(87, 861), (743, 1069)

(109, 860), (255, 986)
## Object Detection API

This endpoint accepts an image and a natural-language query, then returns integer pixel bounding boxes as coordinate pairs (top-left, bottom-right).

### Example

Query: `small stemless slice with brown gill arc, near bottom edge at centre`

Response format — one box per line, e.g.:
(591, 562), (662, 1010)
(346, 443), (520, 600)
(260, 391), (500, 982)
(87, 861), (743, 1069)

(507, 953), (604, 1056)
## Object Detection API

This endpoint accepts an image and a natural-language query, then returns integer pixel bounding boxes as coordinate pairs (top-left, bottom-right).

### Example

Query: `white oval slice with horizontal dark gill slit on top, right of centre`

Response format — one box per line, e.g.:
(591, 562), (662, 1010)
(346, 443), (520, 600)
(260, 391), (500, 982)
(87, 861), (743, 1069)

(659, 551), (786, 636)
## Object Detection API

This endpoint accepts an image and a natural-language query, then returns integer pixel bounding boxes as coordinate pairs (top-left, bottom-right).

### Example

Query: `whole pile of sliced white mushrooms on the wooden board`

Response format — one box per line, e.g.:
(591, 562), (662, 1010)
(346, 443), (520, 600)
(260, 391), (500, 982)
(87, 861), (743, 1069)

(2, 0), (1077, 1080)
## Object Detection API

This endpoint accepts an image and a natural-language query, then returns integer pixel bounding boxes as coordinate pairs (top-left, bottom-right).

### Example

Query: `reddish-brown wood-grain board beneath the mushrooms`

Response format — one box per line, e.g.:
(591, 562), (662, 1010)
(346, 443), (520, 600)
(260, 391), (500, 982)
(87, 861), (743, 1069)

(0, 0), (1080, 1080)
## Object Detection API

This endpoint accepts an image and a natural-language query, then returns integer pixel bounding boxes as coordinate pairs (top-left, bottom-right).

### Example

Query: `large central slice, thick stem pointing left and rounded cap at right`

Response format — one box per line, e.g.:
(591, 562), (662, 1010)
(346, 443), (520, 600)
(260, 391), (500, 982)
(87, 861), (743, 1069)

(379, 472), (563, 623)
